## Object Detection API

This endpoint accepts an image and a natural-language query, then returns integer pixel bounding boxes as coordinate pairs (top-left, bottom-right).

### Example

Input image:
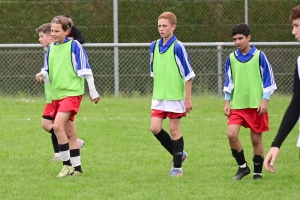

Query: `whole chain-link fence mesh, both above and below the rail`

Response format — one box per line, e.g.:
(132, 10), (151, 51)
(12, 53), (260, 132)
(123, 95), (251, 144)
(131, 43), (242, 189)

(0, 0), (299, 96)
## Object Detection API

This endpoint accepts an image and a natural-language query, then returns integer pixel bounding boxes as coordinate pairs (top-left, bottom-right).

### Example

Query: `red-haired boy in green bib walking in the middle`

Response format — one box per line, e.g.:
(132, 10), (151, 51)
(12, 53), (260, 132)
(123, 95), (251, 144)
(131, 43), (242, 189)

(150, 12), (195, 177)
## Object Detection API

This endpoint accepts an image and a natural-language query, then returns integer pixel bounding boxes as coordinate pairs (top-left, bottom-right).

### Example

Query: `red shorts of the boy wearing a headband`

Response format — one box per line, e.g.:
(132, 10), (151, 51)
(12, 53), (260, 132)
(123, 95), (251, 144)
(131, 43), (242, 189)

(51, 95), (82, 121)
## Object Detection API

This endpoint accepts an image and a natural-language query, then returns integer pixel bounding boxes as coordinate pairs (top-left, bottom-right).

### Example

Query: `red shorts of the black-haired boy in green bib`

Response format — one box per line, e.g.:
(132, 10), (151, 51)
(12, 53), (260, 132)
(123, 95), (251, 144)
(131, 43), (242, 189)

(227, 108), (270, 133)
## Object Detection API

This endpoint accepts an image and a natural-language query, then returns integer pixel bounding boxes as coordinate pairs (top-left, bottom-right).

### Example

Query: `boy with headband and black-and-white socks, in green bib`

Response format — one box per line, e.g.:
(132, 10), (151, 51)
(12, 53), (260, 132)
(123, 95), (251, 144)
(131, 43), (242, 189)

(39, 16), (100, 178)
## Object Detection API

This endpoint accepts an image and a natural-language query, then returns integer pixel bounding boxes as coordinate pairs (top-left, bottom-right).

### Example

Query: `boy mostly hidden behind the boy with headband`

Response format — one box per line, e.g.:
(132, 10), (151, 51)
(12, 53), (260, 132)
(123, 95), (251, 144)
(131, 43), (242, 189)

(36, 23), (84, 161)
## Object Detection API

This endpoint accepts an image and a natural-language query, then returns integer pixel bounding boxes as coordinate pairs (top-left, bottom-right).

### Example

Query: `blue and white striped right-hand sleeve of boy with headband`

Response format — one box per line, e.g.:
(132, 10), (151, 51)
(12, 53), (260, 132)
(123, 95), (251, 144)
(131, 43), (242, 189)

(72, 40), (93, 78)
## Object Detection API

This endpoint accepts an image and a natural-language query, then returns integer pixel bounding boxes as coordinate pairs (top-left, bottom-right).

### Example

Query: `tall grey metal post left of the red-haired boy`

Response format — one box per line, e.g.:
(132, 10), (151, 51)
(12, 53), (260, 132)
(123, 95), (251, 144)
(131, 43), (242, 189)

(113, 0), (119, 96)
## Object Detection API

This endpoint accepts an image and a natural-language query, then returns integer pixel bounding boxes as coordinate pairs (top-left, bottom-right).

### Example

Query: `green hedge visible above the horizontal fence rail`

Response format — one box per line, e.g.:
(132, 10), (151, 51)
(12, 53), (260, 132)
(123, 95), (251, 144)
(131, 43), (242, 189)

(0, 0), (299, 43)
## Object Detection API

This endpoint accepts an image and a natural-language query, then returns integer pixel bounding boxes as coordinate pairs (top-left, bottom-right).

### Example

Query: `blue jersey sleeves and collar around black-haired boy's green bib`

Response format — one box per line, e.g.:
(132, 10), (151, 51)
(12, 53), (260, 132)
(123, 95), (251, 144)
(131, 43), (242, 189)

(223, 46), (277, 94)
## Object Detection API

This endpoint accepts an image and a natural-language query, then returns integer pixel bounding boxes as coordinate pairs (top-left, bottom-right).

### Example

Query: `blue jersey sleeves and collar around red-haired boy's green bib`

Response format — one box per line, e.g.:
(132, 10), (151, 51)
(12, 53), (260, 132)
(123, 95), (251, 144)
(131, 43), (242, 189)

(150, 35), (195, 81)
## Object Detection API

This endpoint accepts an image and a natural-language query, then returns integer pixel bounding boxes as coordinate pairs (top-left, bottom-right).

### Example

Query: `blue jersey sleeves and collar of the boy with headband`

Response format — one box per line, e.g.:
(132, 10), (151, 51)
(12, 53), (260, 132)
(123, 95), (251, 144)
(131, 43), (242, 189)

(43, 38), (93, 78)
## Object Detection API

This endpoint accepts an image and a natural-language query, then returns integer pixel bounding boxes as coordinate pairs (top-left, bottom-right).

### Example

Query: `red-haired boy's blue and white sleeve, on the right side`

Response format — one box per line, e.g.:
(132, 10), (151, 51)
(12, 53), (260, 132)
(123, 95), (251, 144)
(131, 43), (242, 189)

(175, 41), (196, 81)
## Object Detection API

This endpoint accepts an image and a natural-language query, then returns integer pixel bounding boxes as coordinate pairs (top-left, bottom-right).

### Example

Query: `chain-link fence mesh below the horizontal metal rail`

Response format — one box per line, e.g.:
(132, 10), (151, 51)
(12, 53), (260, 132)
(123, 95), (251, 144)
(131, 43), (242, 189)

(0, 46), (299, 97)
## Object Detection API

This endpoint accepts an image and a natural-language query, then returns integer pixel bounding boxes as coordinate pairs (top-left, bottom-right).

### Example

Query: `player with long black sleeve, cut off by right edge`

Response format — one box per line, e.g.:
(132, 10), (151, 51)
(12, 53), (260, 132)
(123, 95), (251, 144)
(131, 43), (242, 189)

(264, 5), (300, 173)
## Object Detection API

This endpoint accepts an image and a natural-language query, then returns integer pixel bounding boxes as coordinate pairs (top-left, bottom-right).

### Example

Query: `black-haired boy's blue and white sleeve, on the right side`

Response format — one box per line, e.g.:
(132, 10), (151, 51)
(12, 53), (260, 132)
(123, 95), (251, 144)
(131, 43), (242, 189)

(259, 52), (277, 94)
